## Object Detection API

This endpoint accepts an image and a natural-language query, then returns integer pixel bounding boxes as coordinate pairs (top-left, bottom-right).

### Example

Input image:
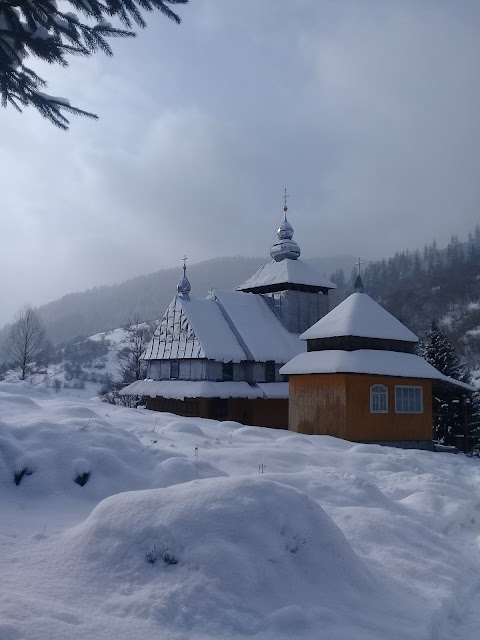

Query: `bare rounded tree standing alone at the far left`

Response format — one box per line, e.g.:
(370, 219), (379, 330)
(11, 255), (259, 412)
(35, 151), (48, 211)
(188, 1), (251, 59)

(6, 304), (45, 380)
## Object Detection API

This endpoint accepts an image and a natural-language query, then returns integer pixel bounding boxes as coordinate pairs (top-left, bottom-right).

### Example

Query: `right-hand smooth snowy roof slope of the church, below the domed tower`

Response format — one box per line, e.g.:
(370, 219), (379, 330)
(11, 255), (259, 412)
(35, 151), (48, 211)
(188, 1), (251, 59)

(212, 290), (305, 363)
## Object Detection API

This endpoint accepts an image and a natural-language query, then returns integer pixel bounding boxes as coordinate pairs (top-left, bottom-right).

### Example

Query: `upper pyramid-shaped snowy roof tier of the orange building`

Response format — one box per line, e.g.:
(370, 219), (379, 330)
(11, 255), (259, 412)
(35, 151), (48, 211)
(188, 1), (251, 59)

(300, 293), (418, 342)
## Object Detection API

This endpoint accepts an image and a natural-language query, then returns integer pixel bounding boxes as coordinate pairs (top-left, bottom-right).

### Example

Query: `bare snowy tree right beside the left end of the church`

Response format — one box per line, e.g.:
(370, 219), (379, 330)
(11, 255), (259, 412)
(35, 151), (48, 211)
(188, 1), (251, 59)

(117, 314), (151, 384)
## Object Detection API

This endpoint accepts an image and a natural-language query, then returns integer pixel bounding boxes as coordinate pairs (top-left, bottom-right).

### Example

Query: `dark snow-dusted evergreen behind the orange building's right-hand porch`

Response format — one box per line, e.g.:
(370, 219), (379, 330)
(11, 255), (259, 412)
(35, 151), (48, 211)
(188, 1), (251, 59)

(420, 322), (471, 445)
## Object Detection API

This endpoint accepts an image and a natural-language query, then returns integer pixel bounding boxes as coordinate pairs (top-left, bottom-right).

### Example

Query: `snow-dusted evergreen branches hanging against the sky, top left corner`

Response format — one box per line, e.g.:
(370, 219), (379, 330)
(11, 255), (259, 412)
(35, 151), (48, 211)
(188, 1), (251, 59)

(0, 0), (188, 129)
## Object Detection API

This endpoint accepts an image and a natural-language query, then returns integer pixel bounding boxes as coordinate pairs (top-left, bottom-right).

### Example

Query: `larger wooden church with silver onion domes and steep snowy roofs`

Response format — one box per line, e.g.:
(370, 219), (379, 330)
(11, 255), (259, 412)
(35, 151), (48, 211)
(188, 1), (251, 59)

(121, 196), (335, 429)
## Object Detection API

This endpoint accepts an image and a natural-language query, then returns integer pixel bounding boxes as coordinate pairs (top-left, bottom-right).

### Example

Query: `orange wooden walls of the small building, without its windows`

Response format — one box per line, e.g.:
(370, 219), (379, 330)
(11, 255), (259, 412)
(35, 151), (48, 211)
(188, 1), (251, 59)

(289, 373), (432, 442)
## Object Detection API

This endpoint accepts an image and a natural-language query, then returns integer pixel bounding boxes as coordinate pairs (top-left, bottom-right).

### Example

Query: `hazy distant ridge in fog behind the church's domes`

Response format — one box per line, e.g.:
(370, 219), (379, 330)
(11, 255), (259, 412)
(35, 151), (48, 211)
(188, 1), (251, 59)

(6, 256), (355, 344)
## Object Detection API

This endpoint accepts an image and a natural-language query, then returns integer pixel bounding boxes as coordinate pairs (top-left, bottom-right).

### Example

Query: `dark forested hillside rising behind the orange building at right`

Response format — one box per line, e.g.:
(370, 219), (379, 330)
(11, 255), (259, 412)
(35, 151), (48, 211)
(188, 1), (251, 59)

(332, 226), (480, 368)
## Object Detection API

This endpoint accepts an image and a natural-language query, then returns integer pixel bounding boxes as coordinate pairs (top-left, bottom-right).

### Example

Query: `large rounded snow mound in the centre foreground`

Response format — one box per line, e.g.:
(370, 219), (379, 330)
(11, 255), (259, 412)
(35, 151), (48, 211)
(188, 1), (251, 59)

(55, 478), (374, 637)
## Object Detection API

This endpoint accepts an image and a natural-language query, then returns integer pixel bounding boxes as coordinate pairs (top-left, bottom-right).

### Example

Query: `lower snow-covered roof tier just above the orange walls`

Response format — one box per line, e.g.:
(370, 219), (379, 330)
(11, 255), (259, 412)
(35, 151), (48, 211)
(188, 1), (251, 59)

(280, 349), (474, 391)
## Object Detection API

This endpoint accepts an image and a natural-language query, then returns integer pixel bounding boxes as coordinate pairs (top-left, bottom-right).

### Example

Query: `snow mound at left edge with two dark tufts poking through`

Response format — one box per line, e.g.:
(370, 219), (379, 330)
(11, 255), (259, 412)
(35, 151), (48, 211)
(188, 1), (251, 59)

(0, 384), (172, 501)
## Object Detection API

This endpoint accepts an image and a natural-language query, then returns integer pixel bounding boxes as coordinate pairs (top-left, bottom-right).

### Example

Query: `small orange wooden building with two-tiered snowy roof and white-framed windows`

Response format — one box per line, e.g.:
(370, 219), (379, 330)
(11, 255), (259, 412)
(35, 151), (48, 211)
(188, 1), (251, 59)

(280, 275), (473, 448)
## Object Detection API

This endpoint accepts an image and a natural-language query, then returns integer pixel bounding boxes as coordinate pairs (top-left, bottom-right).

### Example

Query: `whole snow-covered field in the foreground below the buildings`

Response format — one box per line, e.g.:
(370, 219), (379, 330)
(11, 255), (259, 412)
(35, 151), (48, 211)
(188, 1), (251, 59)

(0, 381), (480, 640)
